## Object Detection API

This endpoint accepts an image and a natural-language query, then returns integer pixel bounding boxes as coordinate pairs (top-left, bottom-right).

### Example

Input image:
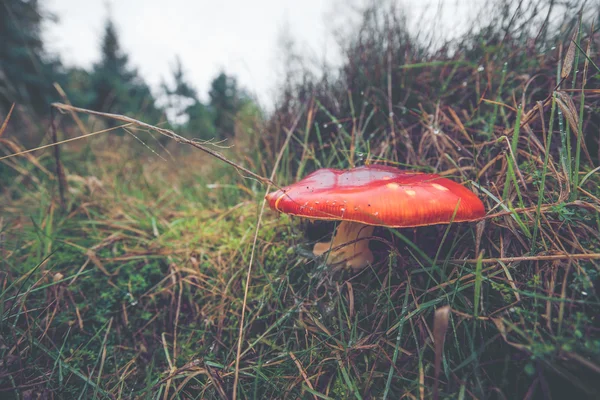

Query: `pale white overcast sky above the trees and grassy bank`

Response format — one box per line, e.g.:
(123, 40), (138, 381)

(42, 0), (484, 107)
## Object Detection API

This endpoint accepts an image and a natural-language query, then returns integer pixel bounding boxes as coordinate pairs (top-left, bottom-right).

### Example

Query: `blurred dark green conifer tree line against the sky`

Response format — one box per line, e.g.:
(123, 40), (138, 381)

(0, 0), (252, 140)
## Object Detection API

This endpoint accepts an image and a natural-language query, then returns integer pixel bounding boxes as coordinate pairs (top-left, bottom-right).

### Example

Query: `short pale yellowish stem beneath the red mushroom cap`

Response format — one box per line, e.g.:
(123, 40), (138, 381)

(313, 221), (375, 270)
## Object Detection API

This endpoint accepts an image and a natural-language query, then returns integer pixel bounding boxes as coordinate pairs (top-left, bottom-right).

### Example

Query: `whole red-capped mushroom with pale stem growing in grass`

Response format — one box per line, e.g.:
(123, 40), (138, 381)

(266, 165), (485, 270)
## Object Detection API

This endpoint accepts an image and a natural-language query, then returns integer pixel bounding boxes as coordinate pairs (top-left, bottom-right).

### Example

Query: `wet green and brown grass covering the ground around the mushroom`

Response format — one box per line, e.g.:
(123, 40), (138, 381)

(0, 0), (600, 399)
